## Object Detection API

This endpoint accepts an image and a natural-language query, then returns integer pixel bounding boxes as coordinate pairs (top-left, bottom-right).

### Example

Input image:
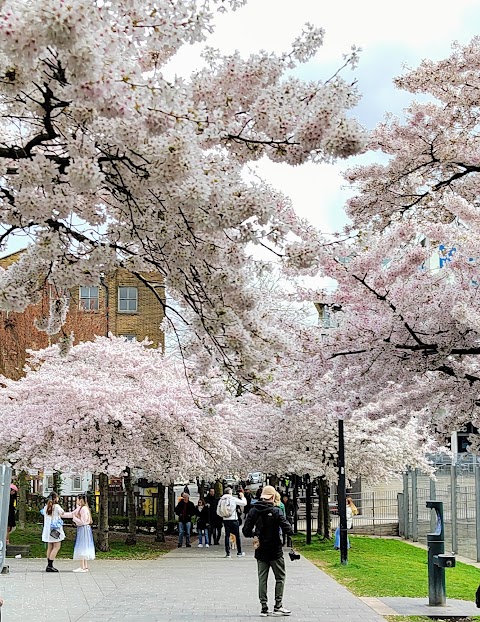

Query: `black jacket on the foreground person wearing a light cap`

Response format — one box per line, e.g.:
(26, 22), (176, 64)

(242, 501), (293, 561)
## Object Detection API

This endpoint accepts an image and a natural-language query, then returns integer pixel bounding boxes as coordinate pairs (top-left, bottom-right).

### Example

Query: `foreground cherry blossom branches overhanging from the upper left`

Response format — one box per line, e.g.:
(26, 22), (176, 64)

(0, 0), (364, 386)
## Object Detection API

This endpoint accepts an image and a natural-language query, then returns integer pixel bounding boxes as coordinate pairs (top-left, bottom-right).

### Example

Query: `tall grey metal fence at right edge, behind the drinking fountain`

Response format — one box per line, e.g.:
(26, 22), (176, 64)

(399, 462), (480, 561)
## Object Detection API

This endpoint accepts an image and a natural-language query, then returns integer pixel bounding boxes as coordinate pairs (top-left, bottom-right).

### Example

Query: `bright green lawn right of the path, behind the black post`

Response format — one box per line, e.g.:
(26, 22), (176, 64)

(294, 535), (480, 604)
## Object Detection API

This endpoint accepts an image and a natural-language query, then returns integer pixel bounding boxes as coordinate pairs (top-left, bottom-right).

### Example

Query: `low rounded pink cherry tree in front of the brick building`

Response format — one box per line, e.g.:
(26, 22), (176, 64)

(0, 337), (235, 548)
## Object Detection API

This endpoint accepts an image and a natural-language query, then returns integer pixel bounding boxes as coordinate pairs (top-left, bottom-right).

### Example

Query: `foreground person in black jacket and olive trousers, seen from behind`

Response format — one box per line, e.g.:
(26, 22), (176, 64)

(243, 486), (292, 618)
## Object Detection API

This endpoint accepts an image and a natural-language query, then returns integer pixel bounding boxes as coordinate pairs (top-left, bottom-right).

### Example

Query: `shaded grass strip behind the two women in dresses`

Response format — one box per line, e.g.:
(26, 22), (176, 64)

(10, 524), (177, 559)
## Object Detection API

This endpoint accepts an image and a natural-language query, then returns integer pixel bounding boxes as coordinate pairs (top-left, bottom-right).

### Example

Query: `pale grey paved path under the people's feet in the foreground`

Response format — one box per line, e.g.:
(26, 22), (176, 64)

(0, 541), (384, 622)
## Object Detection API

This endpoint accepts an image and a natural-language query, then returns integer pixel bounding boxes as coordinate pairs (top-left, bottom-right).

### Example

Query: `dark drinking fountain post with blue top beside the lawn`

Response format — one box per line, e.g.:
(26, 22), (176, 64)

(426, 501), (456, 607)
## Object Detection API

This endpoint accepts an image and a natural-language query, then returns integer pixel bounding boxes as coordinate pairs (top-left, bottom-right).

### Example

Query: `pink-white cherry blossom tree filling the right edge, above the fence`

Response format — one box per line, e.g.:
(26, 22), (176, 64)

(290, 38), (480, 446)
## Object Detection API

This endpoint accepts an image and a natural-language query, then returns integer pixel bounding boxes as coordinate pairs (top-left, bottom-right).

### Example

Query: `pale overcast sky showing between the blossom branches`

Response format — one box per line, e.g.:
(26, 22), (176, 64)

(0, 0), (480, 258)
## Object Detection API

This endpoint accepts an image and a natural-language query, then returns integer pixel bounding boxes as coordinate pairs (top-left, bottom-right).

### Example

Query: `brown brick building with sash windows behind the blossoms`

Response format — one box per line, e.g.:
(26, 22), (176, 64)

(0, 250), (165, 494)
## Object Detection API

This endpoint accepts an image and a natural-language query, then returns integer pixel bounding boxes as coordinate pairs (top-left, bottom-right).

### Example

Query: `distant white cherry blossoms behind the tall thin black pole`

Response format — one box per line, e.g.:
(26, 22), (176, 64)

(213, 280), (440, 483)
